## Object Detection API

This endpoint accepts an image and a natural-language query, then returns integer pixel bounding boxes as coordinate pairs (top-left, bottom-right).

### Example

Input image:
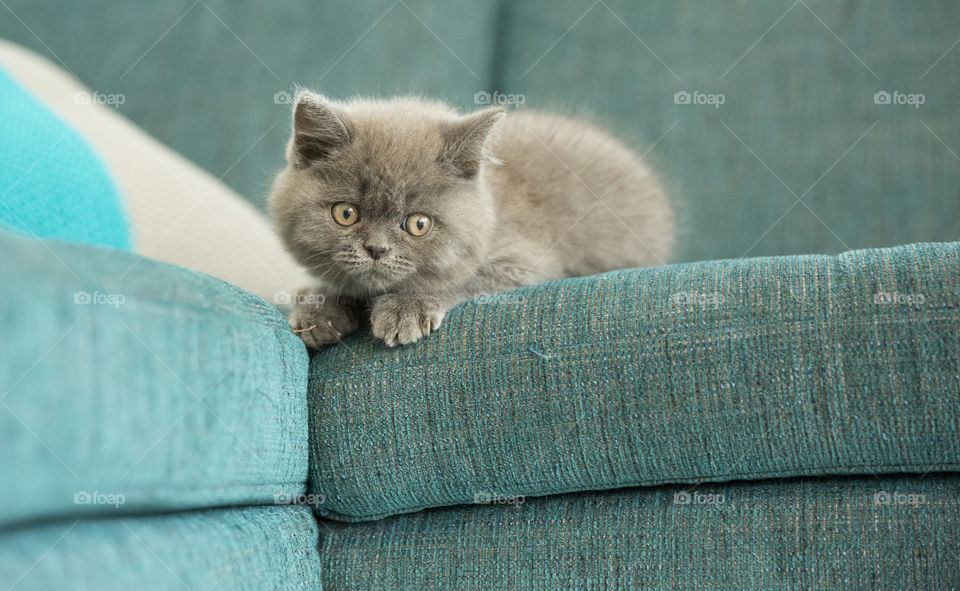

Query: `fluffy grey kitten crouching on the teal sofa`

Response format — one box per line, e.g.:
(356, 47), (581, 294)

(270, 91), (674, 348)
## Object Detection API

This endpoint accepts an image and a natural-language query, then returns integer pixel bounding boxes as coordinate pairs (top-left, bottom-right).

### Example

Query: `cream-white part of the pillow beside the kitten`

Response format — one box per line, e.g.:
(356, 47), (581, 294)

(0, 39), (309, 303)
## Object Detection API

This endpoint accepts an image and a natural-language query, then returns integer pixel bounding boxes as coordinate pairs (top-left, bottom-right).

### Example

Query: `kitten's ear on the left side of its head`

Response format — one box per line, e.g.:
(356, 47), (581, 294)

(289, 91), (350, 167)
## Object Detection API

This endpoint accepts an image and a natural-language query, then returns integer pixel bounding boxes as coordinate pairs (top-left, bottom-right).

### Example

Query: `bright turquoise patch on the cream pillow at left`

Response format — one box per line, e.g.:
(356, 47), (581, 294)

(0, 70), (131, 250)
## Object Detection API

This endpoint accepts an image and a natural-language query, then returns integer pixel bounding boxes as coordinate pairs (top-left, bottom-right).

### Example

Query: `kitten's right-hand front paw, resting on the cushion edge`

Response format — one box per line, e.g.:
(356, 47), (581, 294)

(370, 294), (446, 347)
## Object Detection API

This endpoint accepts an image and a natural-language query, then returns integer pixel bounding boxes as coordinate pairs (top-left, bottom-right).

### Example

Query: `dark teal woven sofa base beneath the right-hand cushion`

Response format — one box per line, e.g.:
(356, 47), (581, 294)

(320, 474), (960, 591)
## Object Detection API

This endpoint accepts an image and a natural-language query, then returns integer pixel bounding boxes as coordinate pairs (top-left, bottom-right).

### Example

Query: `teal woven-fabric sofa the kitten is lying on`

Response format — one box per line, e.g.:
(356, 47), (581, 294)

(0, 0), (960, 590)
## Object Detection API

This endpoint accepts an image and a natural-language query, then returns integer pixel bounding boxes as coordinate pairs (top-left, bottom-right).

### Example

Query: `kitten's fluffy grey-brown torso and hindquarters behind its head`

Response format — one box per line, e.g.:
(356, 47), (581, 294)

(472, 111), (673, 287)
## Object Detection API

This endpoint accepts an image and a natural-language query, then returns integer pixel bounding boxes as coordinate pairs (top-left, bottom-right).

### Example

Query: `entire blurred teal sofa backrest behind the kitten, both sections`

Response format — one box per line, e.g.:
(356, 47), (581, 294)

(0, 0), (960, 261)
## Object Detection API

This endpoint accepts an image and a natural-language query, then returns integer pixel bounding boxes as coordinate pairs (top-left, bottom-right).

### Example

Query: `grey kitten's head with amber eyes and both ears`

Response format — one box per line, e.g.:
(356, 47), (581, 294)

(270, 92), (504, 297)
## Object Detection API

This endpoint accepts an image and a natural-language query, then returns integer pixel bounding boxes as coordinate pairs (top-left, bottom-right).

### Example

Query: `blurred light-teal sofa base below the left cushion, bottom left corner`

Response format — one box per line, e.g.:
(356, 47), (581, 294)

(0, 506), (320, 591)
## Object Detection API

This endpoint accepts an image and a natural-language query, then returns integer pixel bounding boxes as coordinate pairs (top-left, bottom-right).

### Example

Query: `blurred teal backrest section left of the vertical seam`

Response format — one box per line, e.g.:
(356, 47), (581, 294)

(0, 0), (497, 207)
